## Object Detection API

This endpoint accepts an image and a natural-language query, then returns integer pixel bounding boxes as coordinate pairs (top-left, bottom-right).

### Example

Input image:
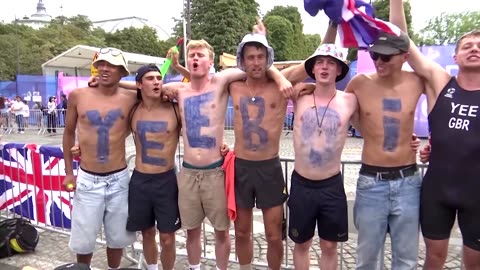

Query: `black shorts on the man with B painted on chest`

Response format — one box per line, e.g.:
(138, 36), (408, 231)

(235, 157), (288, 209)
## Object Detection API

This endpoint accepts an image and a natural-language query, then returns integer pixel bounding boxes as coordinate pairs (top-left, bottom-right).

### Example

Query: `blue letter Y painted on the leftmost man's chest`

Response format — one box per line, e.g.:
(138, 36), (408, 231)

(85, 109), (122, 163)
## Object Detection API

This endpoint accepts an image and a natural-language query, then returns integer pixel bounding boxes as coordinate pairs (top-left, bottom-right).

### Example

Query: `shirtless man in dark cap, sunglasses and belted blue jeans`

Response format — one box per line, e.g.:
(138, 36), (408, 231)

(346, 16), (423, 270)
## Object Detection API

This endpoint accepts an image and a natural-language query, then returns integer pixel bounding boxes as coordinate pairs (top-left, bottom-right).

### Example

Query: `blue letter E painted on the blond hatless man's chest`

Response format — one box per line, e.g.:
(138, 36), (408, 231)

(183, 92), (216, 149)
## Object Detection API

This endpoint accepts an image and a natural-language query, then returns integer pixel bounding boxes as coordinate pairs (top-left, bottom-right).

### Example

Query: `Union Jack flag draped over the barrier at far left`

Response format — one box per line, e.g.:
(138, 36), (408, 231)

(0, 143), (79, 229)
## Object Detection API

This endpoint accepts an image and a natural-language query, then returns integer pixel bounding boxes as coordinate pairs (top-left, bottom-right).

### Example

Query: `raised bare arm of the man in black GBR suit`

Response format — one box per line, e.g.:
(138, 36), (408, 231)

(390, 0), (450, 95)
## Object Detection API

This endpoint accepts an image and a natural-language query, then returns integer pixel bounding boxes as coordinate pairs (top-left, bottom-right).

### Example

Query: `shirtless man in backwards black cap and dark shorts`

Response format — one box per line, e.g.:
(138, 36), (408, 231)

(127, 65), (181, 270)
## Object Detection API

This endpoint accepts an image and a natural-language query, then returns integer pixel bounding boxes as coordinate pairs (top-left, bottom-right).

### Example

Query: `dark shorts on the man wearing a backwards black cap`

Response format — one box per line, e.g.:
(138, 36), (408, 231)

(127, 169), (181, 233)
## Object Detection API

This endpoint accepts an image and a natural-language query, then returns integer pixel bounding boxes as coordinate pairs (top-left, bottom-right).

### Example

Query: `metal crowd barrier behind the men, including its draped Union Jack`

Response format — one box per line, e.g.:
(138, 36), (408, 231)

(0, 143), (464, 269)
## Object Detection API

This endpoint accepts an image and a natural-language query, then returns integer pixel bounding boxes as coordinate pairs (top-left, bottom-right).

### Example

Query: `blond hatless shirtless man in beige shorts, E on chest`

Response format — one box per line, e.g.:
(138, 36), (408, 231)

(120, 40), (291, 270)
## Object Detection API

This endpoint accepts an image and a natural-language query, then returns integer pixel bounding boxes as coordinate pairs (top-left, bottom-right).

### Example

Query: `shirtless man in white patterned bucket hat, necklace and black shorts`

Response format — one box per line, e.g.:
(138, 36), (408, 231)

(288, 44), (357, 270)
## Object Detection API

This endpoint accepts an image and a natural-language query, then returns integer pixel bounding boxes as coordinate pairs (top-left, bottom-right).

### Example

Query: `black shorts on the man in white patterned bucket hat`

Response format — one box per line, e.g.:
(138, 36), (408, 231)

(288, 171), (348, 244)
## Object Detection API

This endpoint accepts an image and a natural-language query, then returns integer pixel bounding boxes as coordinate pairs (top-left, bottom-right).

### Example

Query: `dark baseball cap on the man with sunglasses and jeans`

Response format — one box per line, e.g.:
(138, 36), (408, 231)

(368, 32), (410, 55)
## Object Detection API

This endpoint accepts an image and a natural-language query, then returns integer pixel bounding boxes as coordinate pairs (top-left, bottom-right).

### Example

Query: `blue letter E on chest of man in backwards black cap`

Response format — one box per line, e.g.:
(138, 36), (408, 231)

(137, 121), (168, 166)
